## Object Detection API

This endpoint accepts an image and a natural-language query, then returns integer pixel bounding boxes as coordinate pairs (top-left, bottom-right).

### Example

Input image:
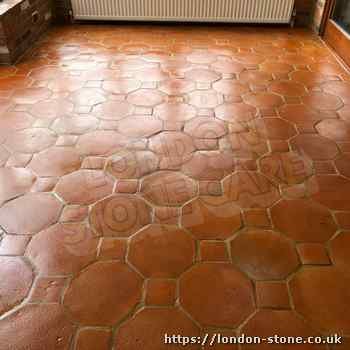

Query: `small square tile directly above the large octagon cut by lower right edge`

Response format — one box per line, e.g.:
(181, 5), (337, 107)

(297, 243), (331, 265)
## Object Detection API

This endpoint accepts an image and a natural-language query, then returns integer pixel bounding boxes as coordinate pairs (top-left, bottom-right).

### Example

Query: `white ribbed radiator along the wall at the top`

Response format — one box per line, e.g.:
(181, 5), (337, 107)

(72, 0), (294, 23)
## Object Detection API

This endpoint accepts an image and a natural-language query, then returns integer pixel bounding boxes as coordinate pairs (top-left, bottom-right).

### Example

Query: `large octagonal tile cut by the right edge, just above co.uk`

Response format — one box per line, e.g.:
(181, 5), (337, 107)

(290, 267), (350, 334)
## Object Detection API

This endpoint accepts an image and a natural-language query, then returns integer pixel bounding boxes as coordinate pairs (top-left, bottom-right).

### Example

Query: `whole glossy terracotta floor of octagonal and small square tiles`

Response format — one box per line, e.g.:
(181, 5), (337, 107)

(0, 25), (350, 350)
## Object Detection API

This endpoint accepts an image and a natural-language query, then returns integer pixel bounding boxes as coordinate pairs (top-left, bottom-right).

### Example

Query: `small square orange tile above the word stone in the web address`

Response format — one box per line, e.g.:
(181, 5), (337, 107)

(255, 281), (290, 309)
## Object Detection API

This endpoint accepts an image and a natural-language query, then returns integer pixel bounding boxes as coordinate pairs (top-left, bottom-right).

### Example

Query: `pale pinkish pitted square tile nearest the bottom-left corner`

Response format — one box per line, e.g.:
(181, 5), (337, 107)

(30, 277), (67, 303)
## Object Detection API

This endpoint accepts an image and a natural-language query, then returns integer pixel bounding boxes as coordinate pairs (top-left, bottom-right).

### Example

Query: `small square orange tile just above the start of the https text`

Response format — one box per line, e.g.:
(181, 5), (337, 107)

(146, 279), (176, 306)
